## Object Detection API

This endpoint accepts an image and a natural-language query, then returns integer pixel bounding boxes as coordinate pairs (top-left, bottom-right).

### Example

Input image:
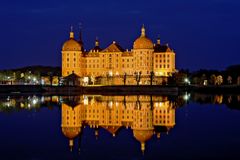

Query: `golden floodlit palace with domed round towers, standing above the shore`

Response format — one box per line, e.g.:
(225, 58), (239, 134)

(62, 26), (176, 84)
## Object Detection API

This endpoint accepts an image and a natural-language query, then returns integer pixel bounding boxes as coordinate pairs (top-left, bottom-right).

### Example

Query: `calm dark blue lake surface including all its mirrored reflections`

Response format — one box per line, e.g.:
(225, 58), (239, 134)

(0, 93), (240, 160)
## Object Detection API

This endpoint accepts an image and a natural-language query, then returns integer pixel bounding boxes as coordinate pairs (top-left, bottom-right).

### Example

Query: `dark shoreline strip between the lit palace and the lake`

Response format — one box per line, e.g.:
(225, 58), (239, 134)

(0, 85), (240, 95)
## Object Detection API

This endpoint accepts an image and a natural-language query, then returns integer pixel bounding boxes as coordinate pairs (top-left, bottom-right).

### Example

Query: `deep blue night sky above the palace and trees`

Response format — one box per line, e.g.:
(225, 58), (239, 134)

(0, 0), (240, 70)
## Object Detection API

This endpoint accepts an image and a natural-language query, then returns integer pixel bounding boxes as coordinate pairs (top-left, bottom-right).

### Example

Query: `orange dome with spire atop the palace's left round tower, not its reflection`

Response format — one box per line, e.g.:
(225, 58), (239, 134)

(62, 30), (82, 51)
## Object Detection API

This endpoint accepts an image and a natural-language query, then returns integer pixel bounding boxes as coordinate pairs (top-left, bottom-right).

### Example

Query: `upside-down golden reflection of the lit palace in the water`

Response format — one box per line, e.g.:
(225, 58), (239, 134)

(62, 96), (176, 152)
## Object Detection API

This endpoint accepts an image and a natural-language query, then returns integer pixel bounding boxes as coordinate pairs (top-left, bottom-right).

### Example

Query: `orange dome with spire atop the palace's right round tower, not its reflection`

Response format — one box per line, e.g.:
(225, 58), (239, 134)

(133, 26), (153, 49)
